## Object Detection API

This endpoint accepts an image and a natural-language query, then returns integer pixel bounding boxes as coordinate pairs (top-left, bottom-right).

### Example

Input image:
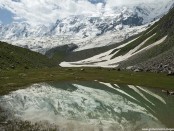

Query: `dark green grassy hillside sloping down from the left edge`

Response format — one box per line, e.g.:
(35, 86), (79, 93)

(0, 42), (56, 69)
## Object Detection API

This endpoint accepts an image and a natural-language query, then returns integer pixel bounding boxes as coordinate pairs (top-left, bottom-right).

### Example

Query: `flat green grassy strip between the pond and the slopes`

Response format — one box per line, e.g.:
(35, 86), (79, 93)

(0, 68), (174, 95)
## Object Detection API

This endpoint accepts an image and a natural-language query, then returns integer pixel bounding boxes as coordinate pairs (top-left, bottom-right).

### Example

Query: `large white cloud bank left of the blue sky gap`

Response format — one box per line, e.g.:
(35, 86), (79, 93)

(0, 0), (102, 24)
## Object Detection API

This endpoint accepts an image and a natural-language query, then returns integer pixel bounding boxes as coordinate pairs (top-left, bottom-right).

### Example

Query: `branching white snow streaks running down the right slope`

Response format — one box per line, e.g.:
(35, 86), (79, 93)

(60, 34), (167, 68)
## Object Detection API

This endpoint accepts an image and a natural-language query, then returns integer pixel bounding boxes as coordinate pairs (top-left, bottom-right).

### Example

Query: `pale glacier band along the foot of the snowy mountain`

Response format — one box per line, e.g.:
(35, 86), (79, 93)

(2, 24), (149, 54)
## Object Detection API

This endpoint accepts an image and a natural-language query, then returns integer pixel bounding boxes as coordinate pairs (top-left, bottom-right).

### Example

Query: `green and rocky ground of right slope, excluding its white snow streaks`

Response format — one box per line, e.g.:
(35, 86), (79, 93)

(116, 8), (174, 71)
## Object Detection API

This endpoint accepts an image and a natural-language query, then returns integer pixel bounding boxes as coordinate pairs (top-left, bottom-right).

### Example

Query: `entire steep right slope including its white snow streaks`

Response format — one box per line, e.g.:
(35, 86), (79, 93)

(60, 8), (174, 71)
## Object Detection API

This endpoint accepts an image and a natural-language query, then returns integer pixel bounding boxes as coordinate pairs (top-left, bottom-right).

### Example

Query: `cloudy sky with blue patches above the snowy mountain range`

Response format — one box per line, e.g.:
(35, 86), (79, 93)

(0, 0), (169, 25)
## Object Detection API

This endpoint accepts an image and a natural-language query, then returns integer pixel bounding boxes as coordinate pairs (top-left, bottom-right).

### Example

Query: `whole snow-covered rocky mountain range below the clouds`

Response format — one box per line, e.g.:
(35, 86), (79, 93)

(0, 0), (174, 52)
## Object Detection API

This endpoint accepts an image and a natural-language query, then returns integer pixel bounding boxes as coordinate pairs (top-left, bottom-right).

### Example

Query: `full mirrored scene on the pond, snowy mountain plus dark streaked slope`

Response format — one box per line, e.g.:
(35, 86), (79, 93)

(0, 82), (174, 131)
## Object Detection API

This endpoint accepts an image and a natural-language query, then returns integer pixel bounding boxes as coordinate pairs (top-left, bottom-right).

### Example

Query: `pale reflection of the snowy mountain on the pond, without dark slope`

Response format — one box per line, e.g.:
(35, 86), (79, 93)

(0, 84), (166, 131)
